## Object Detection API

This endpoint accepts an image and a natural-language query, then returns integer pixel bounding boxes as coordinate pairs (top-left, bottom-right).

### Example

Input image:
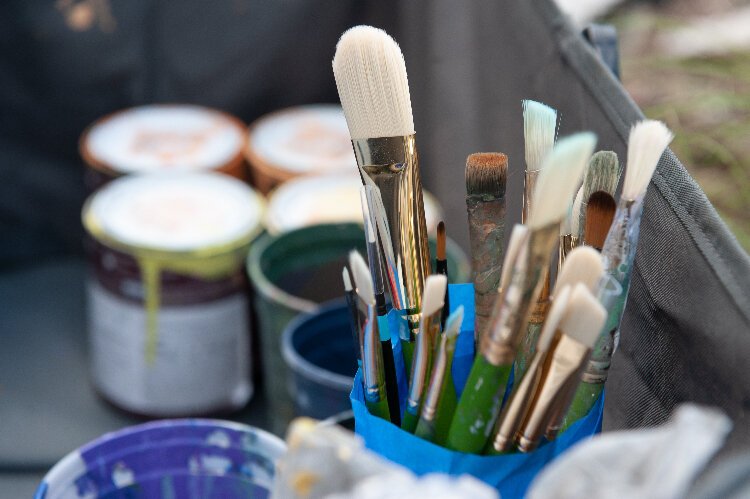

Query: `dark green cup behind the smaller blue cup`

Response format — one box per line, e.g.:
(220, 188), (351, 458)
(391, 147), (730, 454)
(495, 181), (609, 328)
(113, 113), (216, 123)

(248, 223), (469, 435)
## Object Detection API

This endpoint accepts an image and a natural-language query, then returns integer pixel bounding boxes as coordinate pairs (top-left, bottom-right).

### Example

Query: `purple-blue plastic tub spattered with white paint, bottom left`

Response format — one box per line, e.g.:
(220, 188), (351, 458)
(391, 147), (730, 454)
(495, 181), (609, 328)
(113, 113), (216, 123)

(34, 419), (286, 499)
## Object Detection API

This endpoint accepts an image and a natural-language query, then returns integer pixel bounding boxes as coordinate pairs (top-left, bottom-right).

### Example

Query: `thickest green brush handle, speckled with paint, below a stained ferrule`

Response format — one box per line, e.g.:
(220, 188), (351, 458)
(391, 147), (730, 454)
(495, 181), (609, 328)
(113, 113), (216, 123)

(445, 355), (513, 454)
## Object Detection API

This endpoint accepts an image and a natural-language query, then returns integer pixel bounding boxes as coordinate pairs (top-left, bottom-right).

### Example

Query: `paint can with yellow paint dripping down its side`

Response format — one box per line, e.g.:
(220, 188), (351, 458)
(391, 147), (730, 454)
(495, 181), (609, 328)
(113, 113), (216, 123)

(83, 173), (264, 417)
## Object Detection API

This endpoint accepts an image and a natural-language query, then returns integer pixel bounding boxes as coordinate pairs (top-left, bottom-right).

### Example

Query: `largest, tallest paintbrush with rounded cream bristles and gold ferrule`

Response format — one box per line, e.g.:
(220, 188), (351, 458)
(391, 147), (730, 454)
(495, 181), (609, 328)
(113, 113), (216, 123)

(333, 26), (430, 367)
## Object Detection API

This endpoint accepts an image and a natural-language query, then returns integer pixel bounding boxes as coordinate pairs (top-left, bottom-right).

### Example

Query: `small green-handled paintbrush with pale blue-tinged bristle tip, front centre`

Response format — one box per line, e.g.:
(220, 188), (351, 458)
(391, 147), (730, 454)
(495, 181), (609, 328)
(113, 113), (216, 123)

(414, 305), (464, 445)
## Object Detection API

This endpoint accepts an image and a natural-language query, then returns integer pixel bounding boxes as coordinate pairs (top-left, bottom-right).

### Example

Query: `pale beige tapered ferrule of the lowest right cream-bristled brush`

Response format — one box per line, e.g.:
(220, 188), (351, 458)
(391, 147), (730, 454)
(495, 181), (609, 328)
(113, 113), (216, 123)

(518, 334), (591, 452)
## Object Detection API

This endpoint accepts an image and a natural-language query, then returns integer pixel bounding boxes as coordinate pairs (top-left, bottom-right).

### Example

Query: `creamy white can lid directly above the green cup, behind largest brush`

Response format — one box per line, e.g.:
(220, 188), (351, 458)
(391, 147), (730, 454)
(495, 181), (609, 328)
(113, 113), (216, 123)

(264, 174), (442, 235)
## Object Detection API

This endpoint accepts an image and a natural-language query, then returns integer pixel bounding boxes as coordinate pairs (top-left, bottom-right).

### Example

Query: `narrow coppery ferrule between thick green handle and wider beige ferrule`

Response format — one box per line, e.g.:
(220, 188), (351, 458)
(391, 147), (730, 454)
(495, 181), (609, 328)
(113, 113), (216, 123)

(492, 351), (547, 452)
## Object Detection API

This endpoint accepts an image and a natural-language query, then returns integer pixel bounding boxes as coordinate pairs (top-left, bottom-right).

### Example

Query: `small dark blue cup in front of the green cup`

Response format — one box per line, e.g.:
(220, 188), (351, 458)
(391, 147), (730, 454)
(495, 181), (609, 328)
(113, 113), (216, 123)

(281, 300), (357, 419)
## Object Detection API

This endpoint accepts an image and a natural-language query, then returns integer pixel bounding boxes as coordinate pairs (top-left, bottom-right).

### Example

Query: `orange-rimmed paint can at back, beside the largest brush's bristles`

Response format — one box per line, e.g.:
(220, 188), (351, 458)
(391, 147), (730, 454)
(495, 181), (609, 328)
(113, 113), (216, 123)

(245, 104), (359, 193)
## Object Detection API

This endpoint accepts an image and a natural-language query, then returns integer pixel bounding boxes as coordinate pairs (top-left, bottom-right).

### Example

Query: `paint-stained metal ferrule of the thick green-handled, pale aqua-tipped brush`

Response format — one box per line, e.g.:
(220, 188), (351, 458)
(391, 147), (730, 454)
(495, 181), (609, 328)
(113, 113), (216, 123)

(479, 222), (560, 366)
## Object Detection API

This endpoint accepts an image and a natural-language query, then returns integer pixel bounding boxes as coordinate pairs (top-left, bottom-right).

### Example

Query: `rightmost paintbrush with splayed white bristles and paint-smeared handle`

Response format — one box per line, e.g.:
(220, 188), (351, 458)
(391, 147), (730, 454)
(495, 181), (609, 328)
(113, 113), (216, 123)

(564, 120), (673, 427)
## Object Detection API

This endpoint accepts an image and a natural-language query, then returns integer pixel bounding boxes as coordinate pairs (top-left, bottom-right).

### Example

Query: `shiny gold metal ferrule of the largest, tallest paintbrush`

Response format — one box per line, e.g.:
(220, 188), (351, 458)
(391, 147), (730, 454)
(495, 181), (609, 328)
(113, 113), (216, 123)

(352, 134), (430, 333)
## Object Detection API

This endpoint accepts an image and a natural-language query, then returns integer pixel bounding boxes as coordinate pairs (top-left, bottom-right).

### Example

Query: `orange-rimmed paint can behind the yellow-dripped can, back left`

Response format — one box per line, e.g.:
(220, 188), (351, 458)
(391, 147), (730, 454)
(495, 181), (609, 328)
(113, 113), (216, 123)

(79, 104), (247, 192)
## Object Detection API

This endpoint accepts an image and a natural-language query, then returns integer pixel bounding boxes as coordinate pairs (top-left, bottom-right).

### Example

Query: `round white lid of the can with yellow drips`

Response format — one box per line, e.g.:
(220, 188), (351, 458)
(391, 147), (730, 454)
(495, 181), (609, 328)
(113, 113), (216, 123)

(83, 173), (265, 252)
